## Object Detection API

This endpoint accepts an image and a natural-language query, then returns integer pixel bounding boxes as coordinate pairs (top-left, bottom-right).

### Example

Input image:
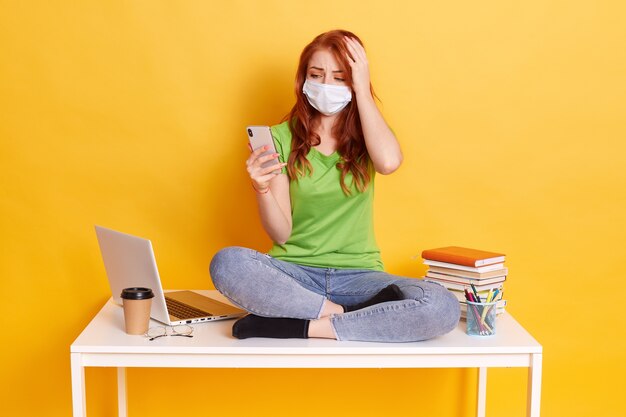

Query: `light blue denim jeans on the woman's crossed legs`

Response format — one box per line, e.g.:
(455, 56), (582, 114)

(210, 247), (460, 342)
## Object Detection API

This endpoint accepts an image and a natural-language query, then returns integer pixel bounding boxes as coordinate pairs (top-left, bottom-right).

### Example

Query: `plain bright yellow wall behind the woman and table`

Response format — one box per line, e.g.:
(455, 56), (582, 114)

(0, 0), (626, 416)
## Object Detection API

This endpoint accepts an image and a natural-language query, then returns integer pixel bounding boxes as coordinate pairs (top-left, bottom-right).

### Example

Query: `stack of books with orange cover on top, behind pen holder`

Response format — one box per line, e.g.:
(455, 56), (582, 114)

(422, 246), (509, 318)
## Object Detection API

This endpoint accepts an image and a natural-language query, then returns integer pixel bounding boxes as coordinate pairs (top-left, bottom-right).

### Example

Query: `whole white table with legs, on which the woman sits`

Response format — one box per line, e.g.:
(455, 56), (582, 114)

(70, 291), (542, 417)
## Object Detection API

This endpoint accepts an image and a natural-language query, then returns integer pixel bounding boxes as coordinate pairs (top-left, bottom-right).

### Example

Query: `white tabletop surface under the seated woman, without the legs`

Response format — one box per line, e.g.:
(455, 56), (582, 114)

(71, 290), (542, 355)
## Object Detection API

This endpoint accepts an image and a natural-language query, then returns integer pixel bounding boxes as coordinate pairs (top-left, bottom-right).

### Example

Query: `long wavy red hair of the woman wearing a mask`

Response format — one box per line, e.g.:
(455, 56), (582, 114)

(285, 30), (373, 195)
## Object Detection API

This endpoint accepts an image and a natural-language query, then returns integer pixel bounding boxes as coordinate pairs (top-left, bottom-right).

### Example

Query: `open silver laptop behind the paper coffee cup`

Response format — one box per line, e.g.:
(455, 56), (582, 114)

(96, 226), (246, 326)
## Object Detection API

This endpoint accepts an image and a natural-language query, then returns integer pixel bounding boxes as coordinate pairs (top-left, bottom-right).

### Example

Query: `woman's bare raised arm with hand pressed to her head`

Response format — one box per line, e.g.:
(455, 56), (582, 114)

(346, 38), (403, 175)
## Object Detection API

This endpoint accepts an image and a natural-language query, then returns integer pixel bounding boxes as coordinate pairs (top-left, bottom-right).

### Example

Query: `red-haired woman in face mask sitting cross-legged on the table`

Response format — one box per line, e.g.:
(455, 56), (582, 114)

(210, 30), (459, 342)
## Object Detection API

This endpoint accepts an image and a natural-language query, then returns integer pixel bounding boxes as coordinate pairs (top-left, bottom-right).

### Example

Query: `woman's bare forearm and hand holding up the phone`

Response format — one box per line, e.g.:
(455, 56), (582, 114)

(246, 147), (292, 244)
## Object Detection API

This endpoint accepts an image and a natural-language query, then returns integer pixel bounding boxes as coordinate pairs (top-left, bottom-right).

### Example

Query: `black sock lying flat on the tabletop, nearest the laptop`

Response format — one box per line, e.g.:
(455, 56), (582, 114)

(233, 314), (309, 339)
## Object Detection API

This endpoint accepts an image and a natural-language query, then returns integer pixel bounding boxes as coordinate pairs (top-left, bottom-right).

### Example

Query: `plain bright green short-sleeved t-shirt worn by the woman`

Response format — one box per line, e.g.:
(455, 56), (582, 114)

(268, 122), (383, 271)
